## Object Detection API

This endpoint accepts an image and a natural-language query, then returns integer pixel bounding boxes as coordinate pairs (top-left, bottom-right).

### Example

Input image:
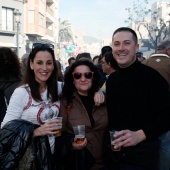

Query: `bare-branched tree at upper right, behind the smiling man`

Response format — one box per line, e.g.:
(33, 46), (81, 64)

(125, 0), (170, 49)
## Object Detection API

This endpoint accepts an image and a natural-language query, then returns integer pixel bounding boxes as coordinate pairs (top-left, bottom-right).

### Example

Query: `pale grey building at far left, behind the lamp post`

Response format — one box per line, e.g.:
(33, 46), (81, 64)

(0, 0), (24, 57)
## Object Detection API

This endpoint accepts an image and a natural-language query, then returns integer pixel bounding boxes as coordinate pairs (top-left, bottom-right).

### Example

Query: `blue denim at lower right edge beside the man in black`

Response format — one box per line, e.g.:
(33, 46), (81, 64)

(159, 131), (170, 170)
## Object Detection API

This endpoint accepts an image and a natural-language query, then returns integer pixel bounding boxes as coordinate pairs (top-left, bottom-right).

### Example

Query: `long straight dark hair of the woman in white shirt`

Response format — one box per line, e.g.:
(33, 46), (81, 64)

(21, 46), (59, 102)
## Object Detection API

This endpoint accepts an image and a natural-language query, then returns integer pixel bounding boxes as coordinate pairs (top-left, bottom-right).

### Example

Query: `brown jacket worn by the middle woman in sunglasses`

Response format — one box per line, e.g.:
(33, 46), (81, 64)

(59, 92), (108, 170)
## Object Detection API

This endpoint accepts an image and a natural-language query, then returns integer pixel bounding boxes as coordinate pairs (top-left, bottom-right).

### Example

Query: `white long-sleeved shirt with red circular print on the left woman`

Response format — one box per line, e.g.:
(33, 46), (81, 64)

(1, 82), (62, 152)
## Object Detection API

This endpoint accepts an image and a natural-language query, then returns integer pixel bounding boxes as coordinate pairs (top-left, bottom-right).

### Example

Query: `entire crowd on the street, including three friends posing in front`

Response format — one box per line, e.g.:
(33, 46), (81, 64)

(0, 27), (170, 170)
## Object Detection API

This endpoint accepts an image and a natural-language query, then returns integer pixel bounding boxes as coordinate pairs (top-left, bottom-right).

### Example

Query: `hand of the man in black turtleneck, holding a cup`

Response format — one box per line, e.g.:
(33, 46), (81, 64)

(112, 130), (146, 149)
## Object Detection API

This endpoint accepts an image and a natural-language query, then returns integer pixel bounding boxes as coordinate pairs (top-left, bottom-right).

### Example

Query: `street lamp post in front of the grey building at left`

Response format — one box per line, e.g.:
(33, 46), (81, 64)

(14, 9), (21, 57)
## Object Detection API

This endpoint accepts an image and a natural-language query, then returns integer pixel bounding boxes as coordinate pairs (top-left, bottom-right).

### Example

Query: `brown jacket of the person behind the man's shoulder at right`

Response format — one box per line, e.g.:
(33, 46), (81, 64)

(142, 54), (170, 91)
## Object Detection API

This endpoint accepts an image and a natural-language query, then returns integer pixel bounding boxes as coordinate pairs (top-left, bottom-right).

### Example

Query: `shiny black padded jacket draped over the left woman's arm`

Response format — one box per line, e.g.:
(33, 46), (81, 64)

(0, 120), (55, 170)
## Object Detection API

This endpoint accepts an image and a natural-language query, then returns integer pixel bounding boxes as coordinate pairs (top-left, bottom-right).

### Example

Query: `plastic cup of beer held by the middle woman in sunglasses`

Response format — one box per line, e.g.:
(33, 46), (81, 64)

(73, 125), (85, 144)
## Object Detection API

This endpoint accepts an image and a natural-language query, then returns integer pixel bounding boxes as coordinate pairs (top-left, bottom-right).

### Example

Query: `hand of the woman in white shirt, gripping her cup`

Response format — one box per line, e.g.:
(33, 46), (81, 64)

(33, 120), (62, 137)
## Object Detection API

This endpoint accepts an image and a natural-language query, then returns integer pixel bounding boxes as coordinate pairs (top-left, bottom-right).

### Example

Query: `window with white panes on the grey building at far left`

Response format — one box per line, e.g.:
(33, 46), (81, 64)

(2, 7), (14, 31)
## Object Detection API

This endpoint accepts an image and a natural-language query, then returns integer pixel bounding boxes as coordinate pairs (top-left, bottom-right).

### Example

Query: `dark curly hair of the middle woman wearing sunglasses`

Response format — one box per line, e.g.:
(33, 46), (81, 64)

(62, 59), (100, 105)
